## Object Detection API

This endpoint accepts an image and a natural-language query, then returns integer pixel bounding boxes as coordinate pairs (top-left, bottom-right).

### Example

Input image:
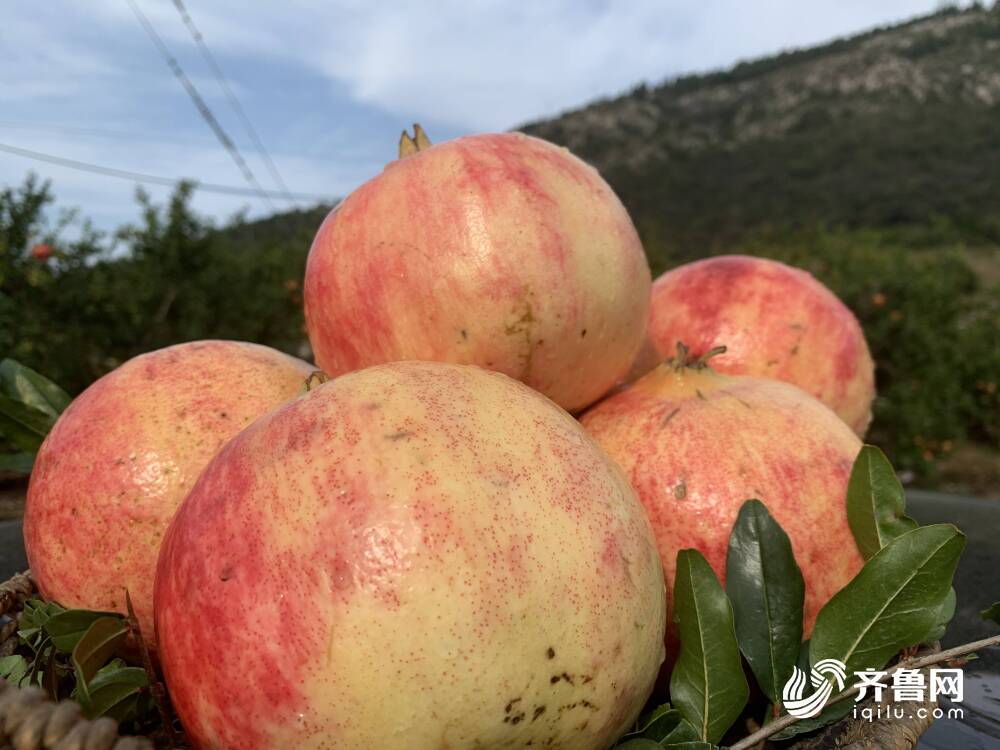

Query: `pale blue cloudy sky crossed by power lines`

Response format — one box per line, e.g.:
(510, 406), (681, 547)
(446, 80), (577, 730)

(0, 0), (968, 235)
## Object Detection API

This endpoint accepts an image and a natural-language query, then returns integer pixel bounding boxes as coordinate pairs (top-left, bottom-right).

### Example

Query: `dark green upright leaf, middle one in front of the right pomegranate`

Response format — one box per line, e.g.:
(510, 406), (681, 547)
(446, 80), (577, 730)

(726, 500), (805, 703)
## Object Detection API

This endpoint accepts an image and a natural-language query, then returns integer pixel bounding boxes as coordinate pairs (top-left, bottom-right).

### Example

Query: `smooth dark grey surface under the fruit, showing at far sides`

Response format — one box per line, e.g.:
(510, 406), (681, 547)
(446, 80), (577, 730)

(0, 491), (1000, 750)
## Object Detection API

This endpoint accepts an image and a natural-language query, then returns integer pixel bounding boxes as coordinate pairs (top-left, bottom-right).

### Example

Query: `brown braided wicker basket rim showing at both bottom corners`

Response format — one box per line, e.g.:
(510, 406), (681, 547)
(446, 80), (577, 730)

(0, 573), (934, 750)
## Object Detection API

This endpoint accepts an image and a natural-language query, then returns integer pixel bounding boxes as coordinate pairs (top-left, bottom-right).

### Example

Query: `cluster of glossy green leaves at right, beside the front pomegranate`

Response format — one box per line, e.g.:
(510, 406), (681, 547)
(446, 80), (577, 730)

(620, 446), (964, 750)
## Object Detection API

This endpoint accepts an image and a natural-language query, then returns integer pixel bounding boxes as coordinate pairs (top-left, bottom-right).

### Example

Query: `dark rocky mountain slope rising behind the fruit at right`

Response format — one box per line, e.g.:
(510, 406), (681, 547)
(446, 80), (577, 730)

(521, 3), (1000, 268)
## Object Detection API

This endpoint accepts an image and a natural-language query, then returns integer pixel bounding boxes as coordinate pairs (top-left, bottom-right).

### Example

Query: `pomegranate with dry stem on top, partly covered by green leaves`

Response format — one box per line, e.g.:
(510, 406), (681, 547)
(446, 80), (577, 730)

(581, 358), (863, 648)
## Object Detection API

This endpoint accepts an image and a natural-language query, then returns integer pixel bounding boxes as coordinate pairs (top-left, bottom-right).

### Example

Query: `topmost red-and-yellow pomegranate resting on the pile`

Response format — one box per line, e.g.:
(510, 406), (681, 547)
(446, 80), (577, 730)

(304, 133), (650, 410)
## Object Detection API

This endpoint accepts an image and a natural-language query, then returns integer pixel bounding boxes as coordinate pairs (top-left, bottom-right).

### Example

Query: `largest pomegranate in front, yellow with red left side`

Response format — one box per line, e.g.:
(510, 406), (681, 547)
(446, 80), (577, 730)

(156, 362), (665, 750)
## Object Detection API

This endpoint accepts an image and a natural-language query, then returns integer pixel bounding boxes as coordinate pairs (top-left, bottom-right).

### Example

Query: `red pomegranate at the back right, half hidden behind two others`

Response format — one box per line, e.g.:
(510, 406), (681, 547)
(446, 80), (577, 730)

(635, 255), (875, 437)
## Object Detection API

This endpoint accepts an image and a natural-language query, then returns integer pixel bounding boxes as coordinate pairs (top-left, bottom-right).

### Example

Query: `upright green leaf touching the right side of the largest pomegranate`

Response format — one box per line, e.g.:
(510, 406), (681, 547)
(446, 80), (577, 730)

(670, 549), (749, 742)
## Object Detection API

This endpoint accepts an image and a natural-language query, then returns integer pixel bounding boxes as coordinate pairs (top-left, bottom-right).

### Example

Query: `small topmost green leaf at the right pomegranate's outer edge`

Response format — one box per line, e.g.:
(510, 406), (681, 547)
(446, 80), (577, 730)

(847, 445), (918, 560)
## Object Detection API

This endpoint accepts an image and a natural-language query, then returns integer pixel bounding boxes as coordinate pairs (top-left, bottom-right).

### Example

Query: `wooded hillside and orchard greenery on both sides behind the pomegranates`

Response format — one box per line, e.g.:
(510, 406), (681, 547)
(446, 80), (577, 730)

(0, 6), (1000, 497)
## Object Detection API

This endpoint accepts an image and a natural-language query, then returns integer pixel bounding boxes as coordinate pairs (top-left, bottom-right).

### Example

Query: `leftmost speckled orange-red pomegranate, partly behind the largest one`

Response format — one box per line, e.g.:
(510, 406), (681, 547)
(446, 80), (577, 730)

(24, 341), (313, 644)
